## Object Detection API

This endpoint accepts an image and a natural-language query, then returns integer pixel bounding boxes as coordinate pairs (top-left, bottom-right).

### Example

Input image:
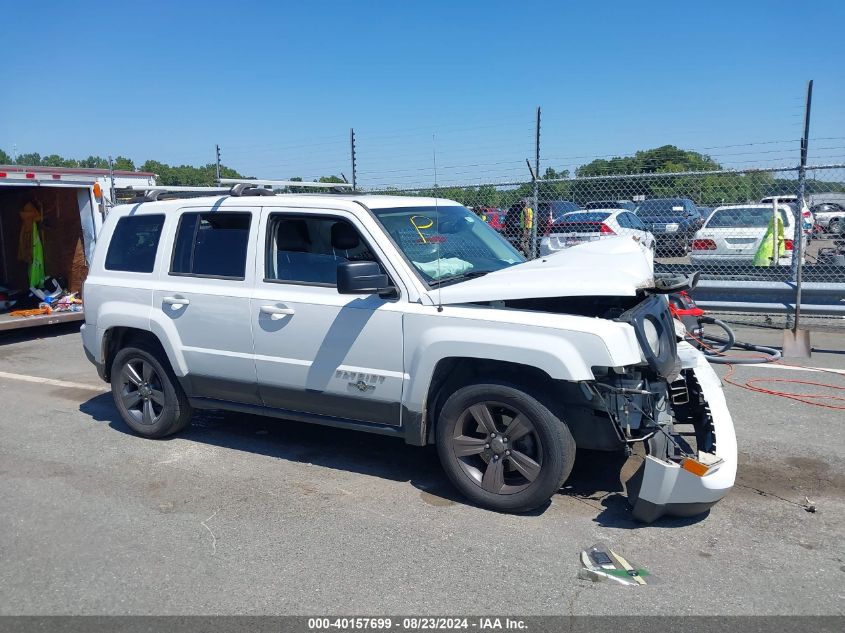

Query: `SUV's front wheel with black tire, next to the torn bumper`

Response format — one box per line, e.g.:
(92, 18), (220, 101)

(436, 383), (575, 512)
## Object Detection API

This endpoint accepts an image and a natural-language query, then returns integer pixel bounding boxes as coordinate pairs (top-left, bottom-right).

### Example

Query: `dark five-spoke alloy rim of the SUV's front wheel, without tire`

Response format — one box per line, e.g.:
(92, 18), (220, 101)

(450, 401), (543, 495)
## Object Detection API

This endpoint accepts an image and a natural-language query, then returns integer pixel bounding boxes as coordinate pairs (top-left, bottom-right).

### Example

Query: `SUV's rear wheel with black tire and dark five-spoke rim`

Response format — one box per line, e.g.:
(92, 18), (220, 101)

(111, 343), (192, 438)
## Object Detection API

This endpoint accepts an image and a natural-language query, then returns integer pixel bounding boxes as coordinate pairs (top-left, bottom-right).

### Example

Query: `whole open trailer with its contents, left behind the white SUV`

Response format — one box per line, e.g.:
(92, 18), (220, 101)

(0, 165), (155, 331)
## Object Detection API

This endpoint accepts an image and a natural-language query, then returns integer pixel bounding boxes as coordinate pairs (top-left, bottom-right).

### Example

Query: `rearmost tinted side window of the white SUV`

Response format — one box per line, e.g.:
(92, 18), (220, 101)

(105, 215), (164, 273)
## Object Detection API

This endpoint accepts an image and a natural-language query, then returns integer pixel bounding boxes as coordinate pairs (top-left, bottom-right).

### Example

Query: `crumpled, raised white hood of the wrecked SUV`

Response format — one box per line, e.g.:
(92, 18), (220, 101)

(430, 237), (654, 304)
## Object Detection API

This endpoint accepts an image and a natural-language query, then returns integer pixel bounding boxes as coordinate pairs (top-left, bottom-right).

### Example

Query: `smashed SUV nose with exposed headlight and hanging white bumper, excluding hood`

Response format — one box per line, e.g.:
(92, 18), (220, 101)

(583, 296), (737, 523)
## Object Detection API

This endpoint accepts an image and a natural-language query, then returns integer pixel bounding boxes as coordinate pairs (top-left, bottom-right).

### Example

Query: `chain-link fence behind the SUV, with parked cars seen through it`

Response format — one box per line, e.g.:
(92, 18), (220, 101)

(362, 165), (845, 283)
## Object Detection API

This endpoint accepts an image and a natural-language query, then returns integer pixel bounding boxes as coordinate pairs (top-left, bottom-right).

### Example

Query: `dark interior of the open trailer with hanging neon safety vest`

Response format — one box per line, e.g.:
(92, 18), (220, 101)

(0, 187), (88, 330)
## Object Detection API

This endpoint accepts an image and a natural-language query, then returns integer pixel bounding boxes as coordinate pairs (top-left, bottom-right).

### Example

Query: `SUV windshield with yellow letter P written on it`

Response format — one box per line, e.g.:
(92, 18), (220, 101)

(373, 206), (525, 283)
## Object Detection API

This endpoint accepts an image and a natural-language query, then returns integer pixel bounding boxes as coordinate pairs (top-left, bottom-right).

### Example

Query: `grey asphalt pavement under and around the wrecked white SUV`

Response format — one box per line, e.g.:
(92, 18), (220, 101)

(0, 320), (845, 615)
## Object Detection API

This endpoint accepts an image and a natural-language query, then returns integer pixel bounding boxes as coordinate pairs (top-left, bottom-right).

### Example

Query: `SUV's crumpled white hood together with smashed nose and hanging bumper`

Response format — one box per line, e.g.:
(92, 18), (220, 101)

(437, 237), (737, 522)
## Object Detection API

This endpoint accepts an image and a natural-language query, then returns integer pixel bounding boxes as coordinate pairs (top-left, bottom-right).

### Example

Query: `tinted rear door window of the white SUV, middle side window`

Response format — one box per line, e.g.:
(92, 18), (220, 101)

(170, 212), (252, 279)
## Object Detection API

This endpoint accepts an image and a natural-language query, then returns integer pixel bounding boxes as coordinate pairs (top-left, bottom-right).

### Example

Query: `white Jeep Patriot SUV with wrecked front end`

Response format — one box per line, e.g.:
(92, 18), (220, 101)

(82, 185), (737, 521)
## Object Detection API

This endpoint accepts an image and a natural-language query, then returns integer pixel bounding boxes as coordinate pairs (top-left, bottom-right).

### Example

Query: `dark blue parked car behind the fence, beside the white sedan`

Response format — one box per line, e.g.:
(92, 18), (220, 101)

(635, 198), (704, 257)
